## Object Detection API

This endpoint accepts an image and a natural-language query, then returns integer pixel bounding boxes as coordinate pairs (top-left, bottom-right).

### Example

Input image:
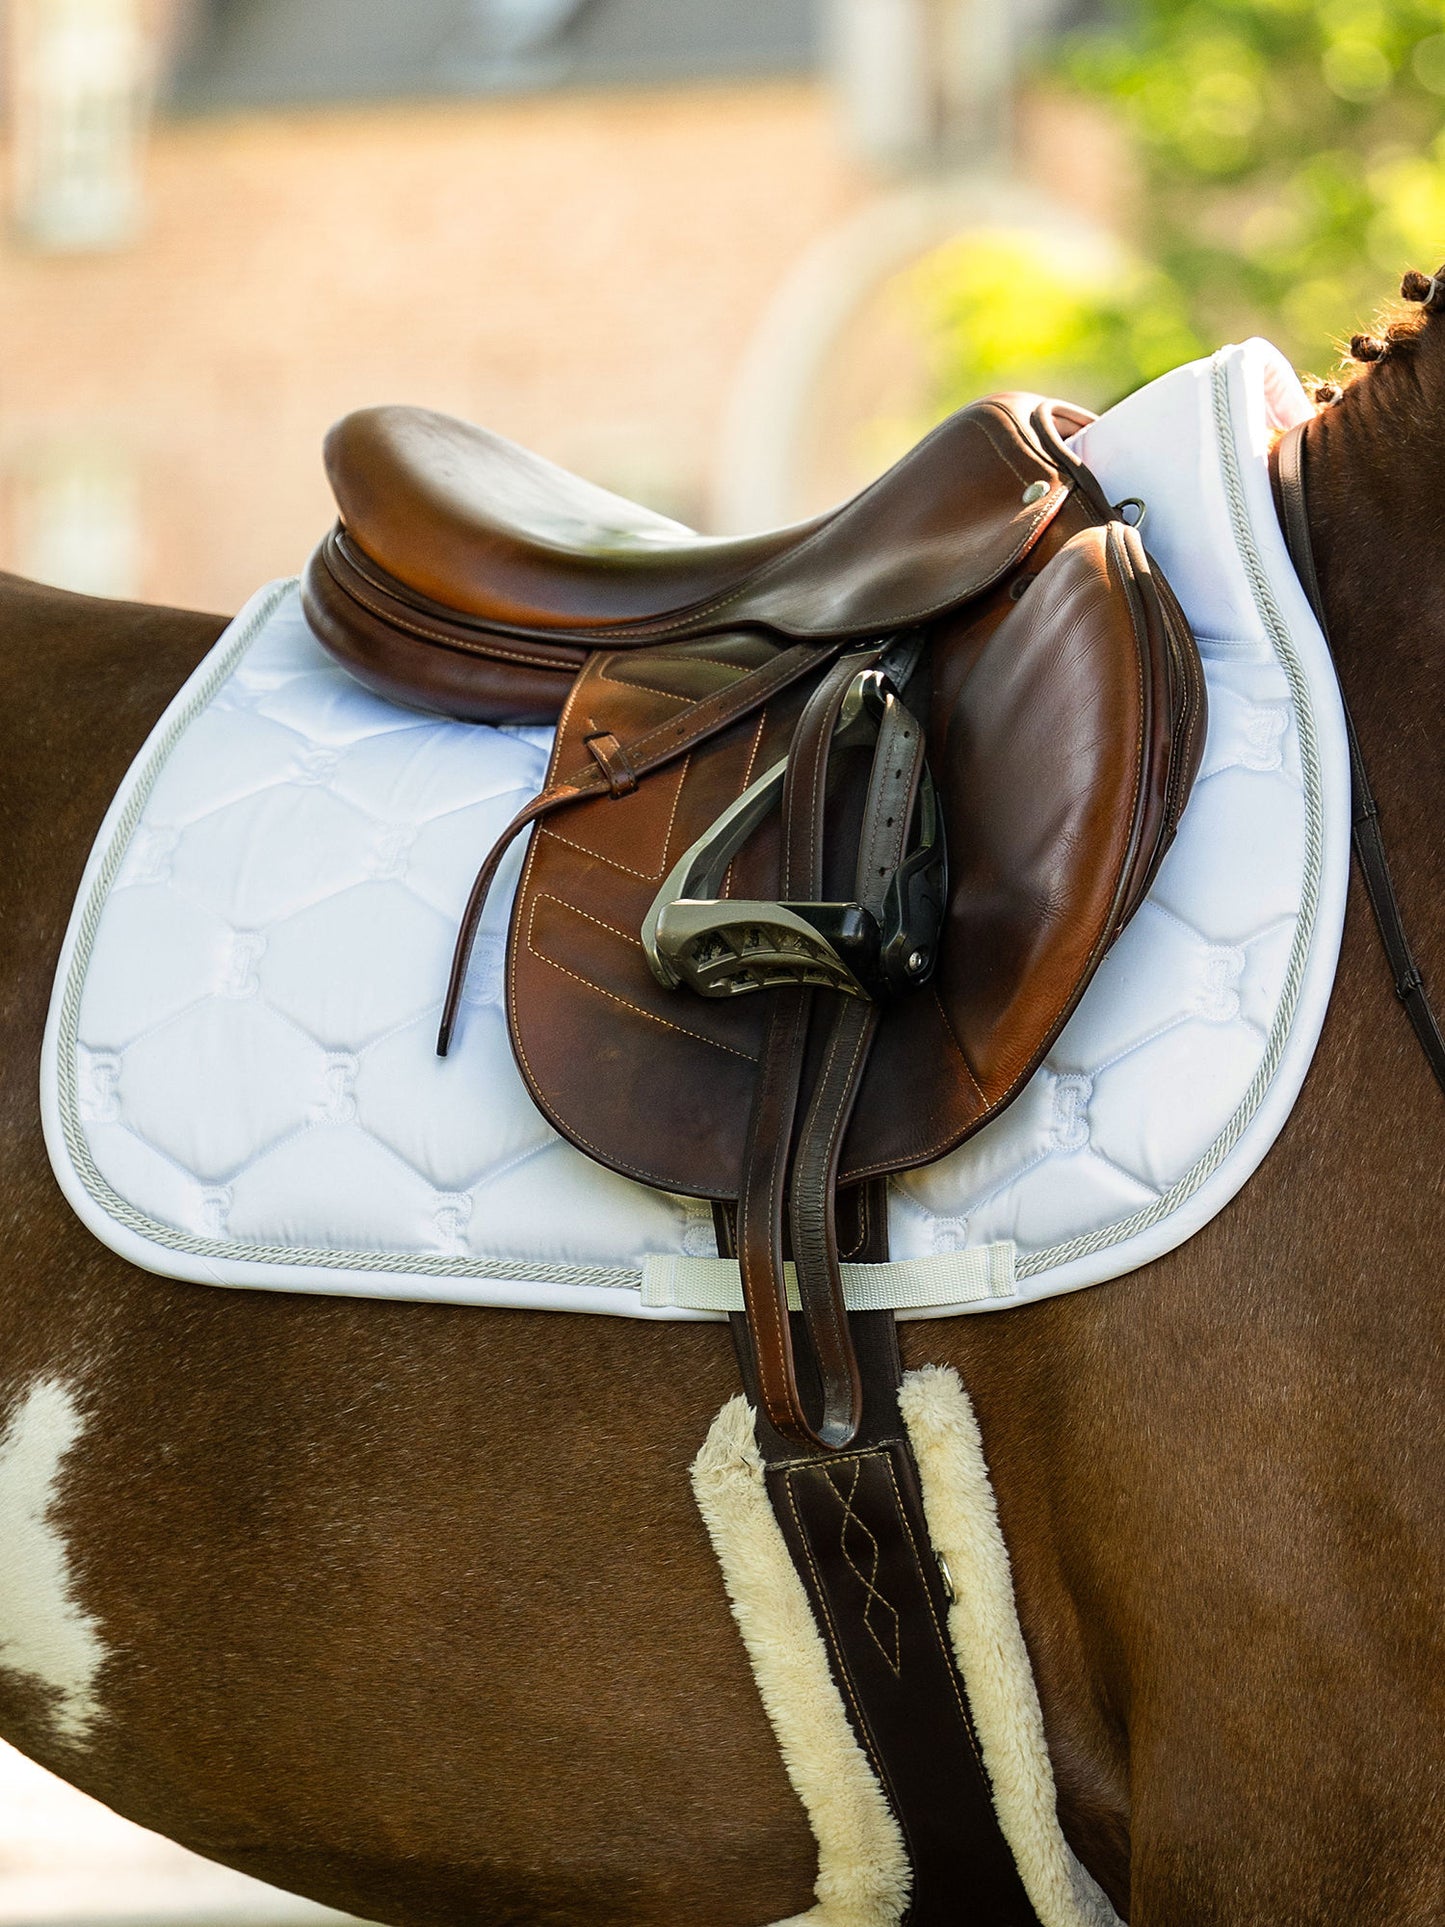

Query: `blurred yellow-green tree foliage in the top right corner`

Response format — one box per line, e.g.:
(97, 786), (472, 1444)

(923, 0), (1445, 403)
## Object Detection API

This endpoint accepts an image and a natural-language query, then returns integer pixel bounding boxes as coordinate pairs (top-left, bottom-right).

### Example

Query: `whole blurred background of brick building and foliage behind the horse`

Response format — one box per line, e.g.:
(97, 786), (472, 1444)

(0, 0), (1445, 1927)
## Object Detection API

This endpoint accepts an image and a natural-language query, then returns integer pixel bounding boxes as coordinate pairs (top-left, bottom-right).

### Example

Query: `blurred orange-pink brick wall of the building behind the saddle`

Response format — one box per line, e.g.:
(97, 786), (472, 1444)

(0, 83), (867, 609)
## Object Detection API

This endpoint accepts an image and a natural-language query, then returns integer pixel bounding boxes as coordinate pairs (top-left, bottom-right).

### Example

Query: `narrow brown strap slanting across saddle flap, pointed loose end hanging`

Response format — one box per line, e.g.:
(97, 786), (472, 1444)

(437, 642), (844, 1058)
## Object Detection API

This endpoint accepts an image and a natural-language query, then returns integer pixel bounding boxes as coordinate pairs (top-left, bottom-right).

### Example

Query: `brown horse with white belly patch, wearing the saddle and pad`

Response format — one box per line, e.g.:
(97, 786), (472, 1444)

(0, 300), (1445, 1927)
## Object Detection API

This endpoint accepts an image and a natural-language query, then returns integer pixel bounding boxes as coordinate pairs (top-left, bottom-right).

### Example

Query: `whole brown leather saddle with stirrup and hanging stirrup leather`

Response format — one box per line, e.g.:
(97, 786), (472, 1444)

(304, 395), (1204, 1447)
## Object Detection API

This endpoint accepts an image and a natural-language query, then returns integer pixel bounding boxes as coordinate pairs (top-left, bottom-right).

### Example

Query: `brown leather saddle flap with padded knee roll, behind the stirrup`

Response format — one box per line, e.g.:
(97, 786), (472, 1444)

(509, 507), (1200, 1199)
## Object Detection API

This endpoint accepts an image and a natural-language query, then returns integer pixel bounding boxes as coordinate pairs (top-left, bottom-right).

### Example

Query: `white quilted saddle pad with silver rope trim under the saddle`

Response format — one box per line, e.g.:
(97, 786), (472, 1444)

(42, 341), (1349, 1318)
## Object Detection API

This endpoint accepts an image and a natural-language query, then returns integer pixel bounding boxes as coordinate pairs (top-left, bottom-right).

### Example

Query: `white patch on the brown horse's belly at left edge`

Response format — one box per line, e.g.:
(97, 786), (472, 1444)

(0, 1378), (106, 1742)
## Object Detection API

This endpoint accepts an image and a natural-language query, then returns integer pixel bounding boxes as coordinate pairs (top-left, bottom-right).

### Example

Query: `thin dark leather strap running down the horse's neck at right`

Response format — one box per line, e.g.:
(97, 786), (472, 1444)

(1274, 422), (1445, 1091)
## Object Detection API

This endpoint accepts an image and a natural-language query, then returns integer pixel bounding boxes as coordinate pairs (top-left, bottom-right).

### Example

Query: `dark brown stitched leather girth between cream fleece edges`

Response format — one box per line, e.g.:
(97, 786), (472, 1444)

(734, 1312), (1038, 1927)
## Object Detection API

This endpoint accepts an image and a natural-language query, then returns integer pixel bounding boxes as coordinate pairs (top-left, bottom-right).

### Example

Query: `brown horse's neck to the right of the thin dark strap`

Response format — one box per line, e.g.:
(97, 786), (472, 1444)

(1306, 341), (1445, 978)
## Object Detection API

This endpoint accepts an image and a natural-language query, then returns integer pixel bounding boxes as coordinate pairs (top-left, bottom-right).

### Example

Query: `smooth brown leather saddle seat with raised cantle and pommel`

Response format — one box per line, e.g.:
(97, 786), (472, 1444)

(302, 397), (1075, 721)
